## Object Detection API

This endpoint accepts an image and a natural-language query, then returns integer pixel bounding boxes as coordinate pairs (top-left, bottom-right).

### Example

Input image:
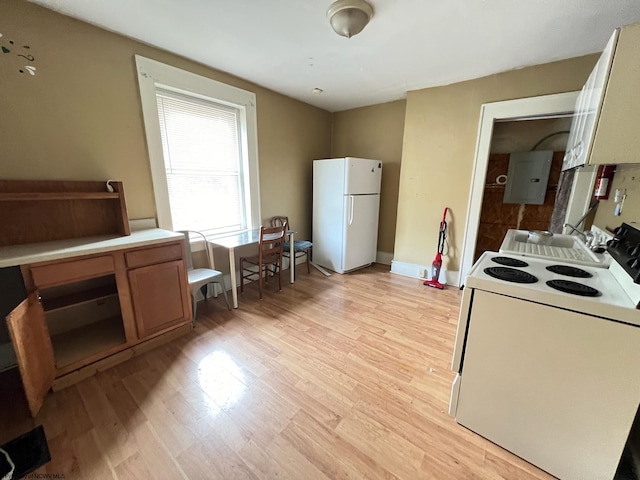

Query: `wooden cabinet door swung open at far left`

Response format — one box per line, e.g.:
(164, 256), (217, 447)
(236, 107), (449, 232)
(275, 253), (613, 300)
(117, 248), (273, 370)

(7, 292), (56, 417)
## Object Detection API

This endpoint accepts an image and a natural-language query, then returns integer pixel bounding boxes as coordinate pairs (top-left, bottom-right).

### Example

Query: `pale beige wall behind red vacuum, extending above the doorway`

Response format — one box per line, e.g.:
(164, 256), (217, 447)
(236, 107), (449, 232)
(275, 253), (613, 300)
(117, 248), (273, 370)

(394, 55), (597, 271)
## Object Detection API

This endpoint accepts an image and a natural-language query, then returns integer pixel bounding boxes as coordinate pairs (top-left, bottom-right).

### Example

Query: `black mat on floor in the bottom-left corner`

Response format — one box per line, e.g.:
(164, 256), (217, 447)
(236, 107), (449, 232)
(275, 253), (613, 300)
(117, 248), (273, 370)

(0, 426), (51, 478)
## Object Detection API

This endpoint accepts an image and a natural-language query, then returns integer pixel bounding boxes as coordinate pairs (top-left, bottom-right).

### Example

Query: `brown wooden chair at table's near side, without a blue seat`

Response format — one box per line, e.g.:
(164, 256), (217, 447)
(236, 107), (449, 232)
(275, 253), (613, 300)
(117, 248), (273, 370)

(240, 226), (285, 299)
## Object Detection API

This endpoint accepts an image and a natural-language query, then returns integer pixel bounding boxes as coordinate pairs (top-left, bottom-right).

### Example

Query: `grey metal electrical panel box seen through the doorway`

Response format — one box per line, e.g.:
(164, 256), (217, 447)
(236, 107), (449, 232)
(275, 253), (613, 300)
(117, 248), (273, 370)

(502, 150), (553, 205)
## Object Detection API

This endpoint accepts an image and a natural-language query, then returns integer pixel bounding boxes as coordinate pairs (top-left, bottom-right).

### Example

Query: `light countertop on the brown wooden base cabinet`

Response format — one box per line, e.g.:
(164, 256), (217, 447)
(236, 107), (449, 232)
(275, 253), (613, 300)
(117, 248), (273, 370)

(0, 228), (184, 268)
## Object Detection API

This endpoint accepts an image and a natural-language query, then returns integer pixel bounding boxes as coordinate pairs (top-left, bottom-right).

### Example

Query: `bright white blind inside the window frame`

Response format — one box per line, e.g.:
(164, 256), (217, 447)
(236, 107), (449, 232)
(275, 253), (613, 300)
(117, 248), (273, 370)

(156, 88), (247, 234)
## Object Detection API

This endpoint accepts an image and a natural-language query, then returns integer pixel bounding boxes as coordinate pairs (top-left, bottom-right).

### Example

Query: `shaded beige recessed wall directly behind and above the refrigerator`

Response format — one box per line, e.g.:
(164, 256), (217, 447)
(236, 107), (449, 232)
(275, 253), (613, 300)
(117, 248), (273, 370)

(331, 100), (406, 255)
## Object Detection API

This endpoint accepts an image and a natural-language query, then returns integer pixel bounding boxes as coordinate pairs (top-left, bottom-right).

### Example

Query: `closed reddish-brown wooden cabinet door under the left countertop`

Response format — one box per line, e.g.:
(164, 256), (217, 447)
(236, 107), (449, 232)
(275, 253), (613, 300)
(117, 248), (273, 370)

(128, 260), (191, 338)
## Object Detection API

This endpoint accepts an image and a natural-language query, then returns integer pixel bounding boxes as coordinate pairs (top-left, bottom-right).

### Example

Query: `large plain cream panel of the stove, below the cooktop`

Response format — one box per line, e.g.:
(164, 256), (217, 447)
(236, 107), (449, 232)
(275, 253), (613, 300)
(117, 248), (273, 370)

(455, 289), (640, 480)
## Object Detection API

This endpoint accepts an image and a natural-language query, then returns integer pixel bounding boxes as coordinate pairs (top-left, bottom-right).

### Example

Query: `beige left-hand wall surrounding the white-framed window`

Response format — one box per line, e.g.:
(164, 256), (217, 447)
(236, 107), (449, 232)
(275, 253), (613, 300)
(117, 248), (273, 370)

(0, 0), (331, 248)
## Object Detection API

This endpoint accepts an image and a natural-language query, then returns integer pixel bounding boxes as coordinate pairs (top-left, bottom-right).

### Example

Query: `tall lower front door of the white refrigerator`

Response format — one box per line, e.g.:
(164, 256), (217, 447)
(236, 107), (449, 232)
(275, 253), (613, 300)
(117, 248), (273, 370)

(340, 195), (380, 273)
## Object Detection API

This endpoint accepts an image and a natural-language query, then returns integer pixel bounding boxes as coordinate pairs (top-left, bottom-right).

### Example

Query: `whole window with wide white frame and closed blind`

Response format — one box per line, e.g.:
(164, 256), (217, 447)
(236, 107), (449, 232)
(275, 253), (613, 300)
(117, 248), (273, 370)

(136, 56), (260, 235)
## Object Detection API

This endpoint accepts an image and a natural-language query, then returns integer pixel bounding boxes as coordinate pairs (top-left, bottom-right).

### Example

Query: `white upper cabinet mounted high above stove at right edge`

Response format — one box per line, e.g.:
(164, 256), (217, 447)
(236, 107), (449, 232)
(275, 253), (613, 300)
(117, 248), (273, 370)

(562, 24), (640, 170)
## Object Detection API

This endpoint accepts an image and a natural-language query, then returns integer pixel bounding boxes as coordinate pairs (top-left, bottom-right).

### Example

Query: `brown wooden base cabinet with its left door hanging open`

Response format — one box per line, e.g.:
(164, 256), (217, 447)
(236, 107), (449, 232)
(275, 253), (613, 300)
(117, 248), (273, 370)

(0, 225), (191, 416)
